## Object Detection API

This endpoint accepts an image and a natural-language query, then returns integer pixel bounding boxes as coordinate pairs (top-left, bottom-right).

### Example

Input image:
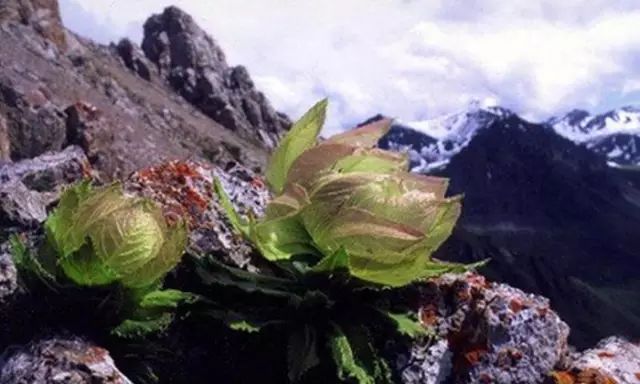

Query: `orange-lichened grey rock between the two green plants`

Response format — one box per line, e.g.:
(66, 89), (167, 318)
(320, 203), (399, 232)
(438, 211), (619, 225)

(125, 161), (269, 270)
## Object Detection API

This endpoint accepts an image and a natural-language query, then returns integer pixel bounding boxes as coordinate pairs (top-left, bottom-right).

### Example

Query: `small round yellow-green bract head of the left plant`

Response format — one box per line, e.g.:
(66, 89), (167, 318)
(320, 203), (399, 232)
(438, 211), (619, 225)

(45, 182), (187, 289)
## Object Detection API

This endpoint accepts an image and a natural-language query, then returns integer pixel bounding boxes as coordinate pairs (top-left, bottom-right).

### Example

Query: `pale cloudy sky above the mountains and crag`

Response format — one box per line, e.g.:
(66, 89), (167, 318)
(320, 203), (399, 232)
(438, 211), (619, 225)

(60, 0), (640, 132)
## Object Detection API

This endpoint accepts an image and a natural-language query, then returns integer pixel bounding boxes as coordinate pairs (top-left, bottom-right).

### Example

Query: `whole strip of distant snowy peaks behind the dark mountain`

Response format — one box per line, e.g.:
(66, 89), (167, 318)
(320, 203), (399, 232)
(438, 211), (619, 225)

(381, 103), (640, 172)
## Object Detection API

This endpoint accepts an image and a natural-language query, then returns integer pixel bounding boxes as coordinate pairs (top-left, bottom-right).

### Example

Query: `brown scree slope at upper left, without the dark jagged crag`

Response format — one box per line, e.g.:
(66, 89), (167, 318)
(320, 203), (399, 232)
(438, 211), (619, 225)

(0, 0), (267, 179)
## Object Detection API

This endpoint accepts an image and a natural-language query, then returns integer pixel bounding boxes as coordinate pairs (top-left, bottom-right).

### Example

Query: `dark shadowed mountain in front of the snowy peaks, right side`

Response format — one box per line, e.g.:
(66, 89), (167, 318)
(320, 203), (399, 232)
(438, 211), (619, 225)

(424, 115), (640, 346)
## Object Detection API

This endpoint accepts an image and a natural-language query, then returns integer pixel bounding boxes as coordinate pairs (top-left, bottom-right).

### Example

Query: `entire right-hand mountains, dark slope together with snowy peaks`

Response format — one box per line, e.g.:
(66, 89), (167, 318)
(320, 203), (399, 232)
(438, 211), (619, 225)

(380, 106), (640, 346)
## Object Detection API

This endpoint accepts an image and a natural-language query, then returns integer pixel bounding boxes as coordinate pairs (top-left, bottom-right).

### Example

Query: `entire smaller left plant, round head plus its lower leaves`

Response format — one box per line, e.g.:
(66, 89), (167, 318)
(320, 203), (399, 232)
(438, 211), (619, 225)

(11, 182), (194, 337)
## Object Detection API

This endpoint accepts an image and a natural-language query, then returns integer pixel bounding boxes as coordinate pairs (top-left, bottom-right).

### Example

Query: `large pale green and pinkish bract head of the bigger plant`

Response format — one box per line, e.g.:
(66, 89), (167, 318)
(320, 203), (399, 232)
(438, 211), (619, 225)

(218, 100), (477, 287)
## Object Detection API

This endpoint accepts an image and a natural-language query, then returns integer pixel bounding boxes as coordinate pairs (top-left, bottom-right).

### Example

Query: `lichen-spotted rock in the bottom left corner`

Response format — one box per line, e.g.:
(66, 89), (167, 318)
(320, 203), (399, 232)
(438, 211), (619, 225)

(0, 338), (132, 384)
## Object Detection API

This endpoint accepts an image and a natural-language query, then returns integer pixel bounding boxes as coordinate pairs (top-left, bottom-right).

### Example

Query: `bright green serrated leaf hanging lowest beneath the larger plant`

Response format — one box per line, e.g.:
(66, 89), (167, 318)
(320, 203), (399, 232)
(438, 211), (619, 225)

(329, 325), (376, 384)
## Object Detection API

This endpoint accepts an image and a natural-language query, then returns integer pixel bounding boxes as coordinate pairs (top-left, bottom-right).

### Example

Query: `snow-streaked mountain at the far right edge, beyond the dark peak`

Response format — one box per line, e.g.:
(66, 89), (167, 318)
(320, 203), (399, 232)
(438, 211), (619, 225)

(547, 106), (640, 165)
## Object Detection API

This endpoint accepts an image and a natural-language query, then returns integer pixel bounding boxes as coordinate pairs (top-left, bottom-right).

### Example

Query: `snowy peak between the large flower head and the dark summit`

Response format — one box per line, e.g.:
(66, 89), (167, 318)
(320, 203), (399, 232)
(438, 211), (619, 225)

(380, 103), (514, 172)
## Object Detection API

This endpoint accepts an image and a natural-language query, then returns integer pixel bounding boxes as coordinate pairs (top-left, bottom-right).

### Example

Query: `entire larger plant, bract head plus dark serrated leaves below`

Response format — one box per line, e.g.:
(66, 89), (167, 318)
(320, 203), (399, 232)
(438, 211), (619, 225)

(196, 100), (477, 384)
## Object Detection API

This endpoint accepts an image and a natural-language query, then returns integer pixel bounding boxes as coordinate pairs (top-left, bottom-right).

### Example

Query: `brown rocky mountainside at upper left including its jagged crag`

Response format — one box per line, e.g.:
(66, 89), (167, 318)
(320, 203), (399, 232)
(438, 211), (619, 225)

(0, 1), (288, 179)
